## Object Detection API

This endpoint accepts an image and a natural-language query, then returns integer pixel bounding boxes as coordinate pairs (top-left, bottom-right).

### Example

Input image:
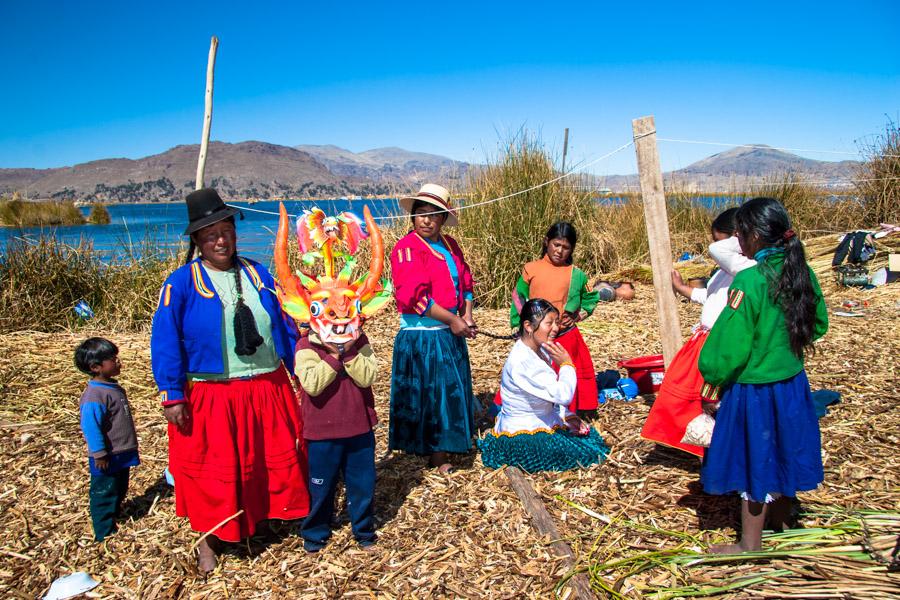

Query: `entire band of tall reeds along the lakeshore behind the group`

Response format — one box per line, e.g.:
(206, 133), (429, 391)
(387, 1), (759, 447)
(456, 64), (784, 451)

(0, 123), (900, 331)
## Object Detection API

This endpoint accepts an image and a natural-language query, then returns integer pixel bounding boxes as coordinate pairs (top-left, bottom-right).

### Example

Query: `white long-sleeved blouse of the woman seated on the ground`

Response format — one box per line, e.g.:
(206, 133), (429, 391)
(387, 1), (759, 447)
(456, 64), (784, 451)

(494, 340), (578, 433)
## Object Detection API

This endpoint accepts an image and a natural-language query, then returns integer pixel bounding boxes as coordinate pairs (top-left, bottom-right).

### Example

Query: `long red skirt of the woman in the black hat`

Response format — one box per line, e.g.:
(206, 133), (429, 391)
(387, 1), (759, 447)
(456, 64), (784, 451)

(169, 368), (309, 542)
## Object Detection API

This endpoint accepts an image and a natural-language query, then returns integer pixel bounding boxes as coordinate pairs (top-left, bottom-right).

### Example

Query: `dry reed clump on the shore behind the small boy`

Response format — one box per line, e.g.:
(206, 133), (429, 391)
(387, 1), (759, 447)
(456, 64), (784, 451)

(0, 235), (179, 332)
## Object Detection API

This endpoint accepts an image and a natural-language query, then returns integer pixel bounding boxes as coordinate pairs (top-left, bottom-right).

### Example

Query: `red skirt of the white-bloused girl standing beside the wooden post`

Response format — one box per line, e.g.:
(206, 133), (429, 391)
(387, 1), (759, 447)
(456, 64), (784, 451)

(641, 329), (709, 458)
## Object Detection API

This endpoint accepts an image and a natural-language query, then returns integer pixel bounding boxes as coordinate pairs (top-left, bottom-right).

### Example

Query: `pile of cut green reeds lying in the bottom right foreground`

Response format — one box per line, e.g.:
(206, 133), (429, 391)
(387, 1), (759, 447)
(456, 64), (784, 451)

(556, 496), (900, 599)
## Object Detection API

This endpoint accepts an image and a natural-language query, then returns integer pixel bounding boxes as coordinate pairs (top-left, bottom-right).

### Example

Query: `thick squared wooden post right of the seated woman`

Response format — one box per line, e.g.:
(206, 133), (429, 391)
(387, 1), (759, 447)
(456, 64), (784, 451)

(631, 116), (681, 367)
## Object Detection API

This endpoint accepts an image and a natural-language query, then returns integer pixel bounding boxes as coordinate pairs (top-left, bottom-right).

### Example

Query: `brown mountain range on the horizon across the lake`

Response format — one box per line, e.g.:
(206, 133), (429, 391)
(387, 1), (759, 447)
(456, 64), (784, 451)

(0, 141), (859, 202)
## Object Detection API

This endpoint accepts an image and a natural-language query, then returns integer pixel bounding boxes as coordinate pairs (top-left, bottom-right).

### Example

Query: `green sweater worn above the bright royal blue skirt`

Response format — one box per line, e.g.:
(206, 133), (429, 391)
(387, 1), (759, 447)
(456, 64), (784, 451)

(699, 254), (828, 386)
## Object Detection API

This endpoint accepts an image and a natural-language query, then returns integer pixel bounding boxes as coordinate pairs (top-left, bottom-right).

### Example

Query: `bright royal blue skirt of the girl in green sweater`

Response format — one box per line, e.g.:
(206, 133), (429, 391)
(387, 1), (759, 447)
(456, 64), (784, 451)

(700, 371), (825, 502)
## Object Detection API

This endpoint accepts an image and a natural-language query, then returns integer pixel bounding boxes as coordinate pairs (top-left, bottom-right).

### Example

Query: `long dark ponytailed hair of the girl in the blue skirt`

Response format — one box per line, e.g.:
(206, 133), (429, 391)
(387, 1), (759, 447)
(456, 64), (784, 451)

(735, 198), (818, 358)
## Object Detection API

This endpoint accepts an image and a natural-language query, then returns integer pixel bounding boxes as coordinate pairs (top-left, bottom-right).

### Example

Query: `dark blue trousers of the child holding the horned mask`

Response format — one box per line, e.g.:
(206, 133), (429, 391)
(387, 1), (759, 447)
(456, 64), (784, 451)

(300, 431), (376, 552)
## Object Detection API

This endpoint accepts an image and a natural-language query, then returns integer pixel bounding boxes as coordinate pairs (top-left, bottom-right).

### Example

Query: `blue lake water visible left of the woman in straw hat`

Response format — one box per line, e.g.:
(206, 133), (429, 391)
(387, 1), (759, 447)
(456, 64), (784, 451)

(0, 200), (402, 262)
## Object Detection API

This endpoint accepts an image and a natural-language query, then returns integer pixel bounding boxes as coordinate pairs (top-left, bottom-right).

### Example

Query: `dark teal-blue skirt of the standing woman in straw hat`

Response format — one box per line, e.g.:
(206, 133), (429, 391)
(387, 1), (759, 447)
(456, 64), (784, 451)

(388, 329), (475, 456)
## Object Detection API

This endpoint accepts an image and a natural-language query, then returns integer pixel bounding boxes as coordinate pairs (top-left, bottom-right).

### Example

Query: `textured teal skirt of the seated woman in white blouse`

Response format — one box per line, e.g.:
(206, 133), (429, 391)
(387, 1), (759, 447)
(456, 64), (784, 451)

(478, 427), (609, 473)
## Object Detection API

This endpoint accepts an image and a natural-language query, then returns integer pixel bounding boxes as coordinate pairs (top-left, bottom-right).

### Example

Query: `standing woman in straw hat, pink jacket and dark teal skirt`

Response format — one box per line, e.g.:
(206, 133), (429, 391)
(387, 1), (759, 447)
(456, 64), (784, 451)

(389, 183), (476, 473)
